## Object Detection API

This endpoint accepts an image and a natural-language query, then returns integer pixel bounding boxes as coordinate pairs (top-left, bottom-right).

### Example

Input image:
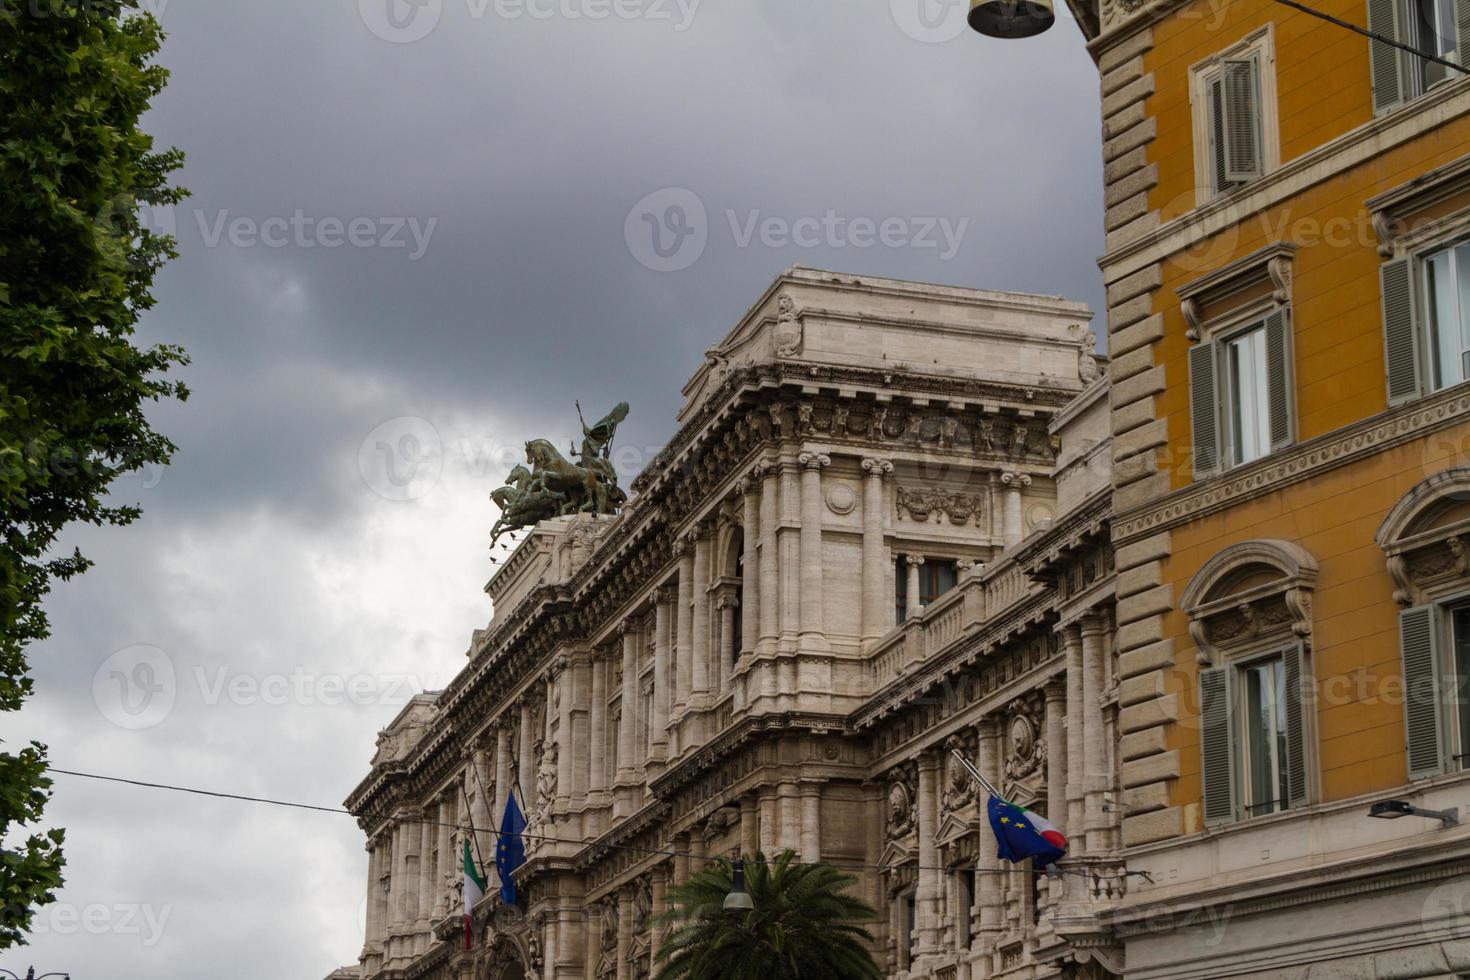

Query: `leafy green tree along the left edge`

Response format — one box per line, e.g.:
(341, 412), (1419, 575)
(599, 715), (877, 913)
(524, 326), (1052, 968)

(0, 0), (188, 949)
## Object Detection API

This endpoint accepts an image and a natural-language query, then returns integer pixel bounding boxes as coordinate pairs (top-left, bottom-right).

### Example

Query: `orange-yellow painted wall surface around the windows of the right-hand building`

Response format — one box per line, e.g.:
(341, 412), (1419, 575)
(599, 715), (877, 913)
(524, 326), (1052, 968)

(1123, 0), (1470, 832)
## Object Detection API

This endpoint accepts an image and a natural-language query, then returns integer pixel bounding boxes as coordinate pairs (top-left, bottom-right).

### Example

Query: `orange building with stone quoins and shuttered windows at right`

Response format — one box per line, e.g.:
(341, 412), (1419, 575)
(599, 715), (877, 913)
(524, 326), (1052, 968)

(1073, 0), (1470, 979)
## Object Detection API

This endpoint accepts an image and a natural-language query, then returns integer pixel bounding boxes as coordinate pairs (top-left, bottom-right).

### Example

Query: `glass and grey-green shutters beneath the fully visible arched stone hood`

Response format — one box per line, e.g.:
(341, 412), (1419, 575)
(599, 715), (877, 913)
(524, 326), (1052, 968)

(1200, 645), (1313, 824)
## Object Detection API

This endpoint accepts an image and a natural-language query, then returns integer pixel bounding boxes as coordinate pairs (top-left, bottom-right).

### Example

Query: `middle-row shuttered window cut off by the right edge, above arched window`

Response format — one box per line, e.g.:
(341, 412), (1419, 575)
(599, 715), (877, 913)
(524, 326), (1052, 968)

(1380, 239), (1470, 404)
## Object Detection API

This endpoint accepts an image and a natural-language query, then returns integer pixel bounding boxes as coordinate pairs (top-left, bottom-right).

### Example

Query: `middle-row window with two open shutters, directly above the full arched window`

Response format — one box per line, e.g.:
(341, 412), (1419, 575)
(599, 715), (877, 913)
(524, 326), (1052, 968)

(1189, 309), (1297, 479)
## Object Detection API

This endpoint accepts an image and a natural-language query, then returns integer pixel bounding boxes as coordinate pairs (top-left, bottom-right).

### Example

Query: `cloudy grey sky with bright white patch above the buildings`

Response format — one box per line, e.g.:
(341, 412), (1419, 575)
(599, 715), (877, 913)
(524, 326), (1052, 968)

(0, 0), (1103, 980)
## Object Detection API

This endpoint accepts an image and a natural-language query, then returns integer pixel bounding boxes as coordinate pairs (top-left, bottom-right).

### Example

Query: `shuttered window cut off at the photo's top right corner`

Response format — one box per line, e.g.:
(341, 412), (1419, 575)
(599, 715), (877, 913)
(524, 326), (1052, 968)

(1369, 0), (1470, 112)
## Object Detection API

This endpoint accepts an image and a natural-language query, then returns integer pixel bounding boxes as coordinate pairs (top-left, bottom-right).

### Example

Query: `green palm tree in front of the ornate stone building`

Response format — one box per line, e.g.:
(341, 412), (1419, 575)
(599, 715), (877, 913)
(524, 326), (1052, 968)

(657, 851), (883, 980)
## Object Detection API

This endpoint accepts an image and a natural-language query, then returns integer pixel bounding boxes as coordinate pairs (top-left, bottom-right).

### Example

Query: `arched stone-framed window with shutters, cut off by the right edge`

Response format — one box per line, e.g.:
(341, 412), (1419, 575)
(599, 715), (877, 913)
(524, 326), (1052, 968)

(1374, 469), (1470, 779)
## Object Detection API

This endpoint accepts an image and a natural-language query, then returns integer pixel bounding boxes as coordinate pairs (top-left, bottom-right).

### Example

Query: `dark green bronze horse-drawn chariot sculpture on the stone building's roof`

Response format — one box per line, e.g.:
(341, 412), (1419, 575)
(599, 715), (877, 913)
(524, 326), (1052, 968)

(490, 401), (628, 545)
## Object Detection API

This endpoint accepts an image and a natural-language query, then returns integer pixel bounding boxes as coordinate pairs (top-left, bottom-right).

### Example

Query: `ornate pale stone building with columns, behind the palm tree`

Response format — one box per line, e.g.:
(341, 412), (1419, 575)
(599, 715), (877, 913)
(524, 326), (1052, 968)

(330, 269), (1130, 980)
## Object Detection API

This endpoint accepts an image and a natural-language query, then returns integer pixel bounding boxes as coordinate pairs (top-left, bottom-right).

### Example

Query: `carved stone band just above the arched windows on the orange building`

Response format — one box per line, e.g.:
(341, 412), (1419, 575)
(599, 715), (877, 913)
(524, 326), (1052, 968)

(1113, 385), (1470, 545)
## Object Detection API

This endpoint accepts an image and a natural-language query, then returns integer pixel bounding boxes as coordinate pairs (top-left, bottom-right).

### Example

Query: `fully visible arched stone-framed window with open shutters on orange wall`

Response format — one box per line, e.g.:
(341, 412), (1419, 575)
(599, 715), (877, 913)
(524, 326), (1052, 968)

(1180, 541), (1317, 824)
